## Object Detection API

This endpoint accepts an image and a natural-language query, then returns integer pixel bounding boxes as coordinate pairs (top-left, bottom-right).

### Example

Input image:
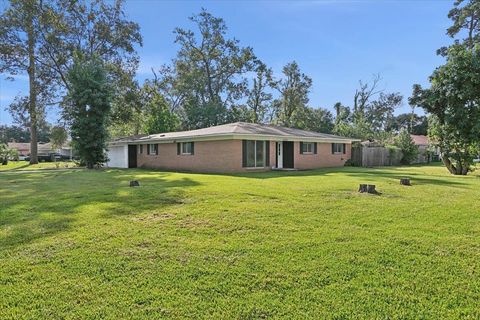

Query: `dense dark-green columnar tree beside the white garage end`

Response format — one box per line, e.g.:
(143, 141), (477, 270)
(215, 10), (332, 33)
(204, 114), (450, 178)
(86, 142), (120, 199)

(65, 55), (112, 169)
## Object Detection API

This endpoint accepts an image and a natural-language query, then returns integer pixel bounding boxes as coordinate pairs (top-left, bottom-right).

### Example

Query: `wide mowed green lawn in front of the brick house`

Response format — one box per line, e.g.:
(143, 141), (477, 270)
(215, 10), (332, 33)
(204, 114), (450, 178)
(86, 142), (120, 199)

(0, 166), (480, 319)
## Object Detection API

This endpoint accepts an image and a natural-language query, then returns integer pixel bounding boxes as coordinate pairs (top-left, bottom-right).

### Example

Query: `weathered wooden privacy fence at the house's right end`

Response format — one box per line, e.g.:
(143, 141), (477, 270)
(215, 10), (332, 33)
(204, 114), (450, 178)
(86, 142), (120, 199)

(352, 141), (402, 167)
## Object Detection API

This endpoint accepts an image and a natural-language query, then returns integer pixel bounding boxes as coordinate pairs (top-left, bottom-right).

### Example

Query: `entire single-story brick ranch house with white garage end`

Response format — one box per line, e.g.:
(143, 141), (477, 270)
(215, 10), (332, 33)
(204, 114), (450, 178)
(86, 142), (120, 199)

(107, 122), (359, 172)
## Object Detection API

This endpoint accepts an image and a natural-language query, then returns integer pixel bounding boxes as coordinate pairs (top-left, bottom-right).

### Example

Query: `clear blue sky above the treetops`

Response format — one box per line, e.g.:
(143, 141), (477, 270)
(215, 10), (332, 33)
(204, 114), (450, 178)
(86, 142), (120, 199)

(0, 0), (453, 123)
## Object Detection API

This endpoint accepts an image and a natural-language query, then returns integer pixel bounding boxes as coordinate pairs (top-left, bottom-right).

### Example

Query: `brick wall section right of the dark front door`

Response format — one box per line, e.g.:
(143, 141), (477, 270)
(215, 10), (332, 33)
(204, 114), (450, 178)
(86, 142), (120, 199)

(293, 142), (352, 170)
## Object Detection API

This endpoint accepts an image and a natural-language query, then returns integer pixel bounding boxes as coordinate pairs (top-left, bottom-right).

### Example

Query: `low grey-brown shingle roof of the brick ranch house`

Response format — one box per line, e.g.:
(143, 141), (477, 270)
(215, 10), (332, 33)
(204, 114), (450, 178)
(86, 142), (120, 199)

(112, 122), (356, 143)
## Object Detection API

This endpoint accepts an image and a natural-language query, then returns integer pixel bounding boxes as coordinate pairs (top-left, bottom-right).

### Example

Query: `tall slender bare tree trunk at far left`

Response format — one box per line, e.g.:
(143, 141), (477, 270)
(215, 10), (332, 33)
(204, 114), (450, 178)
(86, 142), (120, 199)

(27, 6), (38, 164)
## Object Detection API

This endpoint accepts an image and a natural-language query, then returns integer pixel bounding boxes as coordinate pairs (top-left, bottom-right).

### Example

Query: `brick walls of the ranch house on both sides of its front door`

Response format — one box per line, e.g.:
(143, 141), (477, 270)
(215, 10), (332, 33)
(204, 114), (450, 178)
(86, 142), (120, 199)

(137, 140), (350, 172)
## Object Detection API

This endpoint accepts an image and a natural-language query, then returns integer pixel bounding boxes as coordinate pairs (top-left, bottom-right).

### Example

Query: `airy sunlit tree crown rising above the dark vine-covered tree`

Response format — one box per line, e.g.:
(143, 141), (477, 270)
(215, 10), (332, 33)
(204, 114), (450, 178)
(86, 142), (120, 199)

(33, 0), (142, 89)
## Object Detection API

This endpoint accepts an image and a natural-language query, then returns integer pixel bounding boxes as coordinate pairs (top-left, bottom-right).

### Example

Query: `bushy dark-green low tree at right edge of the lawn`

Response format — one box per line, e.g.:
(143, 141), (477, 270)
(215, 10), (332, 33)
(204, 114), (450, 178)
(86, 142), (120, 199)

(410, 45), (480, 175)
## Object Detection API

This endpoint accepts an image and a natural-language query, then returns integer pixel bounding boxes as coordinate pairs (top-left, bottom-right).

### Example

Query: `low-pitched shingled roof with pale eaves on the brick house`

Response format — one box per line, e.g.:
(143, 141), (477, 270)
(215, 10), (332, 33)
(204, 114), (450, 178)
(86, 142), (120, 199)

(111, 122), (360, 144)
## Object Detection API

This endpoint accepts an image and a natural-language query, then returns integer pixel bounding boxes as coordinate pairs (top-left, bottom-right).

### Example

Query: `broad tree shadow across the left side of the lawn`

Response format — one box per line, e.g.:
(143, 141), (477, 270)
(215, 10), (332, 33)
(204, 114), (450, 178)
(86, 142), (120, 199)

(0, 170), (199, 251)
